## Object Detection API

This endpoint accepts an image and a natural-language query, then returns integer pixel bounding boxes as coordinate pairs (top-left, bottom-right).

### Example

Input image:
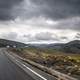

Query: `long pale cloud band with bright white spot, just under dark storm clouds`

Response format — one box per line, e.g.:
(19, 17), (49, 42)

(15, 17), (80, 31)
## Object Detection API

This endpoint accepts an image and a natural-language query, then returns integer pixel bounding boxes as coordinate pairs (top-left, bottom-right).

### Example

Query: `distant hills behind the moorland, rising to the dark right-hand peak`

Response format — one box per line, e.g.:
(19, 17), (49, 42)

(30, 40), (80, 53)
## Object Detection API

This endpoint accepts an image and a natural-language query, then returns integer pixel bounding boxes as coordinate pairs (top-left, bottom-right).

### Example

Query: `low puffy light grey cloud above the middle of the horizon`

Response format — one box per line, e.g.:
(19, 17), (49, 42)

(23, 32), (59, 42)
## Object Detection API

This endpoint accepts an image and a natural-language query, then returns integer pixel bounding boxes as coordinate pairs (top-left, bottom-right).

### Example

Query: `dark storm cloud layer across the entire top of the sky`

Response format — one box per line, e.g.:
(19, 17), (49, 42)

(0, 0), (80, 20)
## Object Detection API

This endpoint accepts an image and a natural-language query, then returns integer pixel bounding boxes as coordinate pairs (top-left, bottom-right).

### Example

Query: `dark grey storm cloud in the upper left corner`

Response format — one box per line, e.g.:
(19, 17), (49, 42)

(0, 0), (22, 20)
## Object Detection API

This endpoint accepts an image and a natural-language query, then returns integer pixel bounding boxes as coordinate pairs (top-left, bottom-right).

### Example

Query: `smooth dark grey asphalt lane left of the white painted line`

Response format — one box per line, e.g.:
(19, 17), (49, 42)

(0, 49), (34, 80)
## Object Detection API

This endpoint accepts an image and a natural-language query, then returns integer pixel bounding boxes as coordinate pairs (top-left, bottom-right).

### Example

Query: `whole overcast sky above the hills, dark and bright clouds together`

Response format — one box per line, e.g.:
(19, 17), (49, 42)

(0, 0), (80, 43)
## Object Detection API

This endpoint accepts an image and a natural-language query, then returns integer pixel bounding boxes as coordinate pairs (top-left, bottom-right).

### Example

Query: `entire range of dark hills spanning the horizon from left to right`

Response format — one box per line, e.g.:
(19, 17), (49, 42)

(0, 39), (80, 53)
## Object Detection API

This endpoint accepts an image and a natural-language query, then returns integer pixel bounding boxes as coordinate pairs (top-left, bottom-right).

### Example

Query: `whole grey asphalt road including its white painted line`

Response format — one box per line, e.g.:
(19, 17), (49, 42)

(0, 49), (56, 80)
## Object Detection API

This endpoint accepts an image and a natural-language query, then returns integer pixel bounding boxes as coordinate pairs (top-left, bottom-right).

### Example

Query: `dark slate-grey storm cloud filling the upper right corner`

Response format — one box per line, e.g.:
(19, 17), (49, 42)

(32, 0), (80, 20)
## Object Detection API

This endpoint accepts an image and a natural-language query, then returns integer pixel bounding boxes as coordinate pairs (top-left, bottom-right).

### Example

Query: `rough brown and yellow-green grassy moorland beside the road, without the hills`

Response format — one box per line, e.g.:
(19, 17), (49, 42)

(12, 47), (80, 79)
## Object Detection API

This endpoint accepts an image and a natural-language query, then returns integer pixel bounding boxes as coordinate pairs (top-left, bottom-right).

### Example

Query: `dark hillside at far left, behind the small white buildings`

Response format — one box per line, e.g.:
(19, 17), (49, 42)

(0, 39), (27, 47)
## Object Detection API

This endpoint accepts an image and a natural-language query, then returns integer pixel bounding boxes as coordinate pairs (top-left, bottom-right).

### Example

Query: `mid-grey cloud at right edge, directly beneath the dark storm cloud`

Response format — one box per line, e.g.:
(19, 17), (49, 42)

(55, 17), (80, 31)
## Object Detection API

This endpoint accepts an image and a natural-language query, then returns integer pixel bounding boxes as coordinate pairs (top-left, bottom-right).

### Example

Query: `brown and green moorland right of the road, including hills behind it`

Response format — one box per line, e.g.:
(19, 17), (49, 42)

(9, 40), (80, 79)
